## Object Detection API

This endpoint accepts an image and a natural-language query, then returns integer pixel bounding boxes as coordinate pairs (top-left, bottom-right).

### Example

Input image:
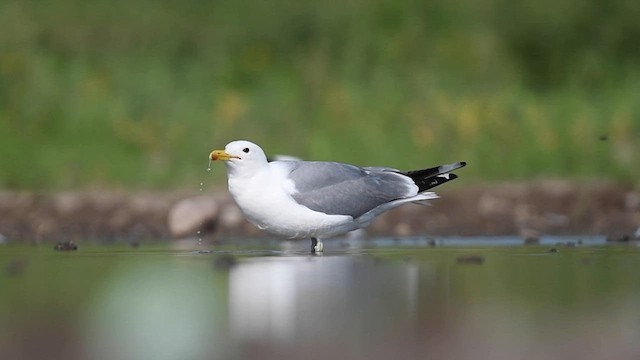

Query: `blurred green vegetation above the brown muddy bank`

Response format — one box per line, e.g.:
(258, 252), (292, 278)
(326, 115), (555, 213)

(0, 0), (640, 189)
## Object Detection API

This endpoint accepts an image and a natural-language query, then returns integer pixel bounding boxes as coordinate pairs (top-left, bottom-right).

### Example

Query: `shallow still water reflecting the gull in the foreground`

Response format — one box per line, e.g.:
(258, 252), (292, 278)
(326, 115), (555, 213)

(0, 237), (640, 359)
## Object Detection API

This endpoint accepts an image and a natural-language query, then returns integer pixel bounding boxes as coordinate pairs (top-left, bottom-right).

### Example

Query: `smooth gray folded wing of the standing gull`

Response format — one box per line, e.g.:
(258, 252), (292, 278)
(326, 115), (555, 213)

(289, 161), (417, 219)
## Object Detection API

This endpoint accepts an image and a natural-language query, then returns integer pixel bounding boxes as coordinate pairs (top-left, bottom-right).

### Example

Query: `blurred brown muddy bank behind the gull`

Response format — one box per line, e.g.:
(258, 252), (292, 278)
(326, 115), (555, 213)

(0, 181), (640, 242)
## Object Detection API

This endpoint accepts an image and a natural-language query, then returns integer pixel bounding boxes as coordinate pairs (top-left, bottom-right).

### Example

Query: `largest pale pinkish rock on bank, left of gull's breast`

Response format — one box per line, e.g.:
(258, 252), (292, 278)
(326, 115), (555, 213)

(168, 195), (219, 238)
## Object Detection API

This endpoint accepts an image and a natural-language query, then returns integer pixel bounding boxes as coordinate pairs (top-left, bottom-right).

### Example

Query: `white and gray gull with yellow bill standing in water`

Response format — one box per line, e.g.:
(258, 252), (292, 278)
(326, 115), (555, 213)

(209, 140), (466, 253)
